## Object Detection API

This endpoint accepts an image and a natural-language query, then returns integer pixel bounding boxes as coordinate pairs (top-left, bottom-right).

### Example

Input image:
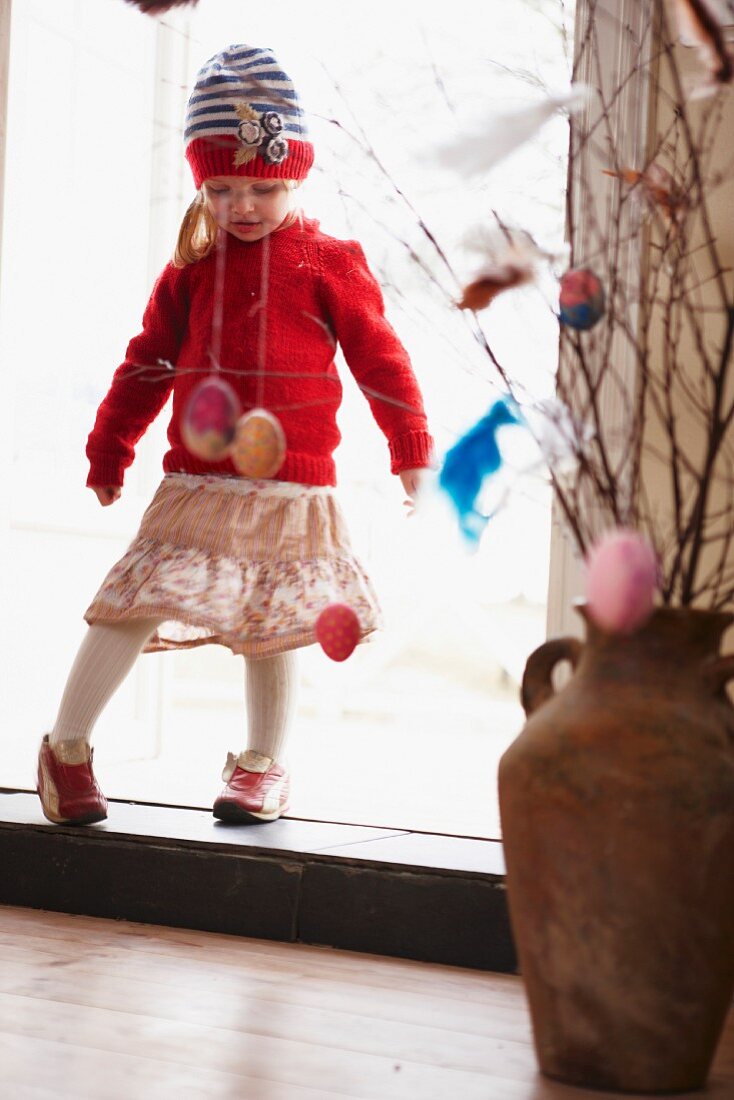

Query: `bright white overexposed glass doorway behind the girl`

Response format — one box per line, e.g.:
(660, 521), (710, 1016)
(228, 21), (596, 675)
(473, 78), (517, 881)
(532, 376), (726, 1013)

(0, 0), (568, 836)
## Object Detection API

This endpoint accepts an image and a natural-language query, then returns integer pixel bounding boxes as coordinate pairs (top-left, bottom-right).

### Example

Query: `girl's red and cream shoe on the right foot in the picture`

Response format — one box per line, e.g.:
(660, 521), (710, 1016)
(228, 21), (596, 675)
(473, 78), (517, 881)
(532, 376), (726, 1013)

(213, 749), (291, 822)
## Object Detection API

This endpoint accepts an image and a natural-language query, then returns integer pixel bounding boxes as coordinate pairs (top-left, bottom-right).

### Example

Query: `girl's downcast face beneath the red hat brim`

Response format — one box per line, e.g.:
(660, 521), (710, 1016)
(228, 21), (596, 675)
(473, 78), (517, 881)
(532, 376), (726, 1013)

(204, 176), (291, 241)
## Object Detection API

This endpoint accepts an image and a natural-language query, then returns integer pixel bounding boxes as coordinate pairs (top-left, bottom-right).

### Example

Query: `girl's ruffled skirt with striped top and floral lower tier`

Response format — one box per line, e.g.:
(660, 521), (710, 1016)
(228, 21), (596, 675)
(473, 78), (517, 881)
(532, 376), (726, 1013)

(85, 474), (381, 657)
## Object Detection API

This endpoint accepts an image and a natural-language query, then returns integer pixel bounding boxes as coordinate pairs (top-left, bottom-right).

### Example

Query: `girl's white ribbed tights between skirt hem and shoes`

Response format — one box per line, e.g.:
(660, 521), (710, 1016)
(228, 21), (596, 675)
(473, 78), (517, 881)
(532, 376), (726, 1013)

(51, 618), (298, 760)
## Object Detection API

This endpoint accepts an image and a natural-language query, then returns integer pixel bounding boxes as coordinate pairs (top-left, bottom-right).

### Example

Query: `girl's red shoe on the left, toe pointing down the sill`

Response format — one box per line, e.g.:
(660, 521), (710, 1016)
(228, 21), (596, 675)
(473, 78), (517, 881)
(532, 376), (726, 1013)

(37, 734), (107, 825)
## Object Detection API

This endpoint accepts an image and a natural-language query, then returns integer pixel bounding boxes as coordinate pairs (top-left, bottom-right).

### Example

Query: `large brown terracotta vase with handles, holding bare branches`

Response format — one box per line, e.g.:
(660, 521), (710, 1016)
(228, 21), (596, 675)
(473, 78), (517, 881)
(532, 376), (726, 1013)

(499, 608), (734, 1092)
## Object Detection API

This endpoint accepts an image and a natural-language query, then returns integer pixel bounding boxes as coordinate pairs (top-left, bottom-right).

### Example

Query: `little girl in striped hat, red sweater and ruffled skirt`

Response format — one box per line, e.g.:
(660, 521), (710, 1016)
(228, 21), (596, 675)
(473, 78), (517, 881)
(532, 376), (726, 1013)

(37, 45), (431, 824)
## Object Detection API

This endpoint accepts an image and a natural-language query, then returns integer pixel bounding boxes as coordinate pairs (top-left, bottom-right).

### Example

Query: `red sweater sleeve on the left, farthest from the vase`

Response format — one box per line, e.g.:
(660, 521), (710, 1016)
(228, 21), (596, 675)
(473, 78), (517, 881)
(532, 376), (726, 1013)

(87, 264), (187, 486)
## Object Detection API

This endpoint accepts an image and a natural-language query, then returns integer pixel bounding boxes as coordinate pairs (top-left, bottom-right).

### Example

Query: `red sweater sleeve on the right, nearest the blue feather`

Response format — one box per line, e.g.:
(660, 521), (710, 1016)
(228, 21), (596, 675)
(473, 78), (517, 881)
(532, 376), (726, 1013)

(319, 239), (434, 474)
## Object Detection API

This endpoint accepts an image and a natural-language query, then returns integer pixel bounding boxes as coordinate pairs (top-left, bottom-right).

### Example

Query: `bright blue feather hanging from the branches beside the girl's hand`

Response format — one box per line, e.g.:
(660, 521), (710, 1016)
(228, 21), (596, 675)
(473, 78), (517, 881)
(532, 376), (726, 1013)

(438, 398), (522, 547)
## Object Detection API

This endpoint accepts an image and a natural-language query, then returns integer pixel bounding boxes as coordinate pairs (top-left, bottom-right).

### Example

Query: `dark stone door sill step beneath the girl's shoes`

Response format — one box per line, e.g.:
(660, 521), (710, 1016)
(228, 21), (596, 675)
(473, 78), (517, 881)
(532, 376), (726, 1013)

(0, 791), (516, 972)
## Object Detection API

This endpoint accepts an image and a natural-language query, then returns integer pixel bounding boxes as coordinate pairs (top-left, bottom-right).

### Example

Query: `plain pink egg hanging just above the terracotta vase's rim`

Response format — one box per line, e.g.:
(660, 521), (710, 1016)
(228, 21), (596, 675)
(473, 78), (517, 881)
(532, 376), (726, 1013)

(587, 530), (658, 634)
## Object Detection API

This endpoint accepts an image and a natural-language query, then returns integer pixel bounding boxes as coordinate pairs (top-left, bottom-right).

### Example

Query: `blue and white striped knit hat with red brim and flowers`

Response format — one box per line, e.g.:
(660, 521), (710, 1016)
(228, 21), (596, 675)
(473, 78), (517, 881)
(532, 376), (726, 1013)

(184, 46), (314, 187)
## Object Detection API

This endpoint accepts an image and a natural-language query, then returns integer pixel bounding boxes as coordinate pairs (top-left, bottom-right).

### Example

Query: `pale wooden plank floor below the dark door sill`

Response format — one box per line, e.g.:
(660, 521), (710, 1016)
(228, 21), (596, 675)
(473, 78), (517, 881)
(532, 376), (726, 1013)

(0, 908), (734, 1100)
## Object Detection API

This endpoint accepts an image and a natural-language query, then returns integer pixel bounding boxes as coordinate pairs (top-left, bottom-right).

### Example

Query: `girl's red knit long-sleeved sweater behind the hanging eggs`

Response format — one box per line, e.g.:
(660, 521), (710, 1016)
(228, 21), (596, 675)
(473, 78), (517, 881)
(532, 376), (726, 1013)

(87, 220), (431, 486)
